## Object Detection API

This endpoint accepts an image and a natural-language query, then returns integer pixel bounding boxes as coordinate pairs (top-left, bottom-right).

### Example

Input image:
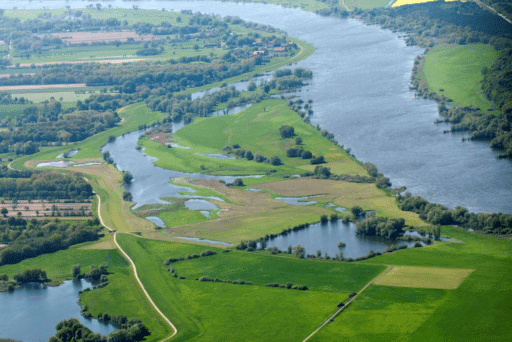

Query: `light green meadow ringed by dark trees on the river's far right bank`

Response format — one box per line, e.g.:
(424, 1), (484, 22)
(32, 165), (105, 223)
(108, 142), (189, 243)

(424, 44), (497, 110)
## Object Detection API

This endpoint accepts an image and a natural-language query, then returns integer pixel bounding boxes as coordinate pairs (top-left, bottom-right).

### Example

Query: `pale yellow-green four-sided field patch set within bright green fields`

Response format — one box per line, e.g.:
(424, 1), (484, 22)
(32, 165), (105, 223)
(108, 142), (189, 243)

(374, 266), (474, 290)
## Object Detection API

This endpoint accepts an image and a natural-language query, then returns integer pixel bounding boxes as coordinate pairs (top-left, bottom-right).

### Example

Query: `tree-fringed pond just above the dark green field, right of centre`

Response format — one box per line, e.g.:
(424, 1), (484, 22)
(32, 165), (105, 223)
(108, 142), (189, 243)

(267, 220), (413, 258)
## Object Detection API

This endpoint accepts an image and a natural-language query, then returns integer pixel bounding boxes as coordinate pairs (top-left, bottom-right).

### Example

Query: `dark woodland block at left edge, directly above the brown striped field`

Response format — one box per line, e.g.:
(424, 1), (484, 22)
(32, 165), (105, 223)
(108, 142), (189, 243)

(0, 170), (93, 200)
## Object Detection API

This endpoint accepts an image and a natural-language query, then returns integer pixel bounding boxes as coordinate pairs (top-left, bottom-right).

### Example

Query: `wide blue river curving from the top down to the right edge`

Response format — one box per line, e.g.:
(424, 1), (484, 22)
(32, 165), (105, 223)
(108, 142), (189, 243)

(4, 0), (512, 213)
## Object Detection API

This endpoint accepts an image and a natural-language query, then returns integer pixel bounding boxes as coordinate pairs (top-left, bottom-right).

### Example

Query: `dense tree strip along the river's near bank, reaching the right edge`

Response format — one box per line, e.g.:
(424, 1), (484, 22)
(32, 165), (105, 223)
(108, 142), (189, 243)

(398, 193), (512, 234)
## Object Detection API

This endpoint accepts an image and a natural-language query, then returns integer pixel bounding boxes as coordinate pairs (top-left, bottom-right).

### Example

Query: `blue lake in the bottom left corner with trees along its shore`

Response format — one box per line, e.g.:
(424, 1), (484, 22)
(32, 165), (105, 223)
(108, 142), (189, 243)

(0, 279), (116, 342)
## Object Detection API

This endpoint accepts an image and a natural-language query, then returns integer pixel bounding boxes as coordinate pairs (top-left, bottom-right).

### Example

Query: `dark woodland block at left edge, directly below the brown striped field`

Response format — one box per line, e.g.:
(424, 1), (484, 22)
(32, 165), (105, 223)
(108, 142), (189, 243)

(0, 217), (102, 266)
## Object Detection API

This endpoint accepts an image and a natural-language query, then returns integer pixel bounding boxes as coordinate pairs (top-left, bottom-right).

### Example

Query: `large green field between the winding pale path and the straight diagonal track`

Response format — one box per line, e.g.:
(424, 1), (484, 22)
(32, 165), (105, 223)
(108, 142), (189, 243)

(118, 235), (383, 341)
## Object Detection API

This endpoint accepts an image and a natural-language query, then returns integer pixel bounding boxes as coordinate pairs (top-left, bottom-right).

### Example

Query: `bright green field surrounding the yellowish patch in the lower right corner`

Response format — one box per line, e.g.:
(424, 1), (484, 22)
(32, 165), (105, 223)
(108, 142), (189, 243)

(312, 226), (512, 341)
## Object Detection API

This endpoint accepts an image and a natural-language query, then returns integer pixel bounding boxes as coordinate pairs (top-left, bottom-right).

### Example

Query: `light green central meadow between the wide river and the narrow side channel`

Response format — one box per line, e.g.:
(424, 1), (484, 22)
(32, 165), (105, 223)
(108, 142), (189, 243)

(141, 100), (364, 174)
